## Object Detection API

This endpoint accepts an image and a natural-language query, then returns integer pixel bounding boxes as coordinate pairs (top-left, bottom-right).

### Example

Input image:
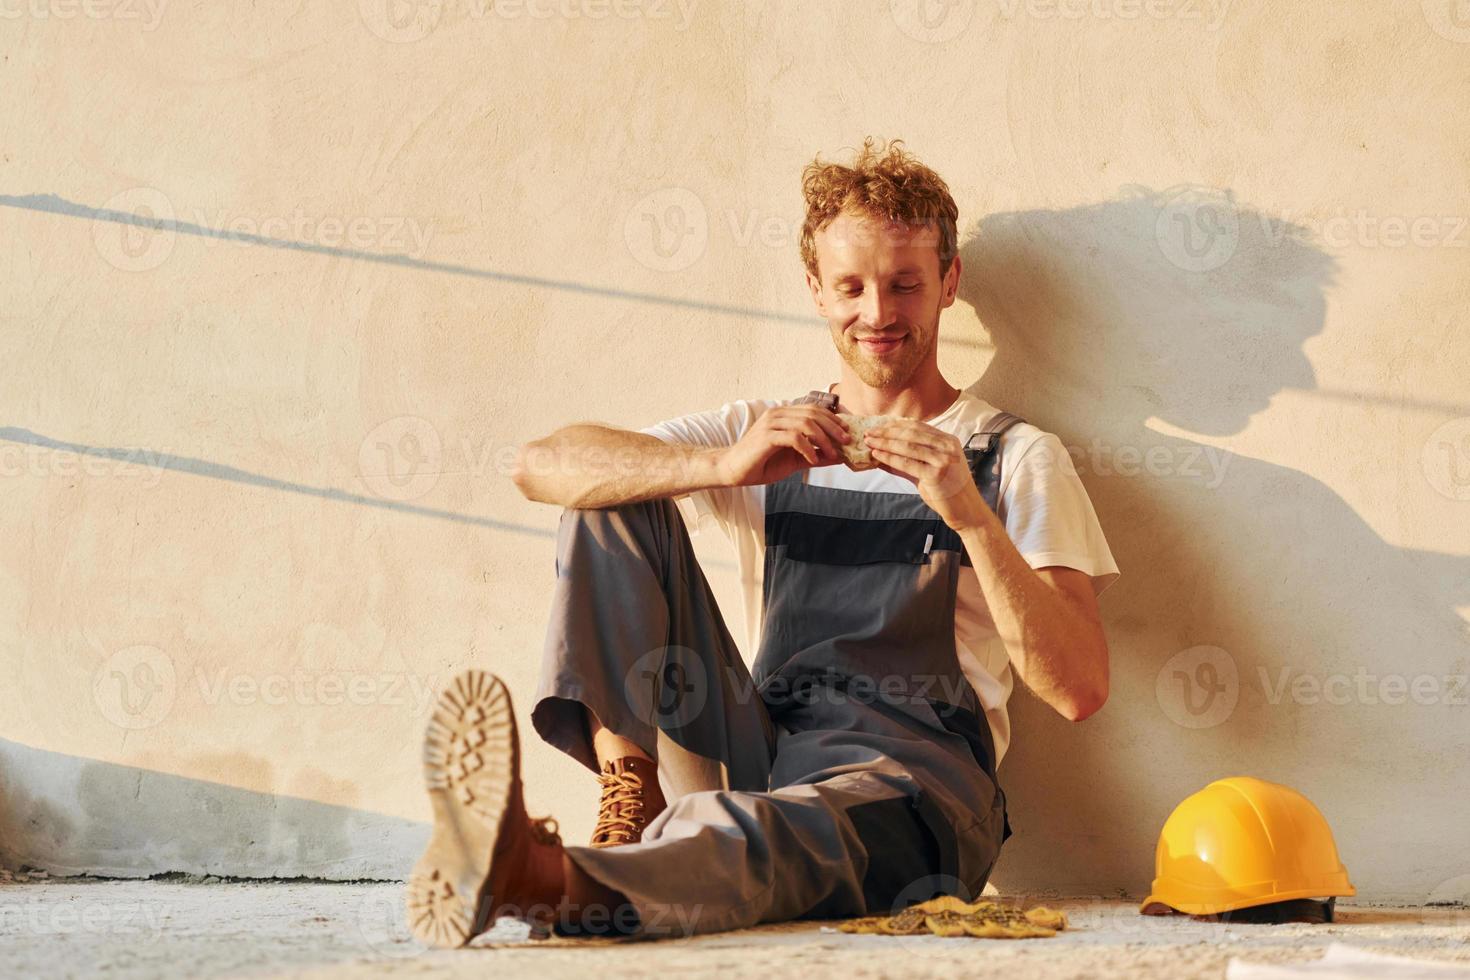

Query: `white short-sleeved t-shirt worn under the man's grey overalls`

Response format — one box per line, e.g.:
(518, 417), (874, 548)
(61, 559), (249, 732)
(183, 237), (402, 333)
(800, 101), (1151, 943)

(639, 391), (1119, 765)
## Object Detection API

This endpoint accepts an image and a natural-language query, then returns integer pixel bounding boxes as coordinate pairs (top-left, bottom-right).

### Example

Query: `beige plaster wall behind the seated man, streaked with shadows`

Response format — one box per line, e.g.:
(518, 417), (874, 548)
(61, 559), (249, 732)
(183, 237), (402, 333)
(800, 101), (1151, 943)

(0, 0), (1470, 901)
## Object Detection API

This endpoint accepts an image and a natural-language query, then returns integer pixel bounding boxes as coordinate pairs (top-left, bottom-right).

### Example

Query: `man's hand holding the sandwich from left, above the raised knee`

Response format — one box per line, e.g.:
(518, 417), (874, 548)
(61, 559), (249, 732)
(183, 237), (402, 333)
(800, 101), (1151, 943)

(719, 404), (853, 486)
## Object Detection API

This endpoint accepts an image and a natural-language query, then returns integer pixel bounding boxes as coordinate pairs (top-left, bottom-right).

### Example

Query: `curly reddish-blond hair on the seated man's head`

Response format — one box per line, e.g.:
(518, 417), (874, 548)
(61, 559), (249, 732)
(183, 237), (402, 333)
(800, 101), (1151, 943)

(801, 137), (960, 279)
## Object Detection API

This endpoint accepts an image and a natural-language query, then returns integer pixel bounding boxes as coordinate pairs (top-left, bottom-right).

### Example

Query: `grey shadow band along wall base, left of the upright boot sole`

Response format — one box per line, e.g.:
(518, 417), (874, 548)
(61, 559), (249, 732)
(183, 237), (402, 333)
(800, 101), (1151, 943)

(0, 739), (429, 882)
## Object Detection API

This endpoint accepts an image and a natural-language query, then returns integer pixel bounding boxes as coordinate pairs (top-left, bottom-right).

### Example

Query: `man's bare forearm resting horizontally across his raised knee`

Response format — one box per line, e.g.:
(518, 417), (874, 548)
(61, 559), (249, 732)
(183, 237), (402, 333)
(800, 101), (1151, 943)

(512, 423), (722, 508)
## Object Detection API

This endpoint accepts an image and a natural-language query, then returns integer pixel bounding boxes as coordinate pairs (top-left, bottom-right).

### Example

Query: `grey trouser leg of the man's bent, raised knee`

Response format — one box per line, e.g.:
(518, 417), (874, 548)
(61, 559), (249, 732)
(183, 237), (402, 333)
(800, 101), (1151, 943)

(531, 500), (776, 799)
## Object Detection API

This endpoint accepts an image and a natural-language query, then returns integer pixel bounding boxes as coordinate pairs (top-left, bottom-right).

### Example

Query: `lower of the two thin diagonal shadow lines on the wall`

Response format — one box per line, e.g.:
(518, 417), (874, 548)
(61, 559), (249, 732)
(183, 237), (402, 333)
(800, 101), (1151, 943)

(0, 426), (735, 569)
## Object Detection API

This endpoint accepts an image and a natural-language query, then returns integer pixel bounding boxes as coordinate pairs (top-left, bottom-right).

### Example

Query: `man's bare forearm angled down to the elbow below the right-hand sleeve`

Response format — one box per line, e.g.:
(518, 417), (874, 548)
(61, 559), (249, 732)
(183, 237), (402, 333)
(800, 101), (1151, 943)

(960, 510), (1108, 720)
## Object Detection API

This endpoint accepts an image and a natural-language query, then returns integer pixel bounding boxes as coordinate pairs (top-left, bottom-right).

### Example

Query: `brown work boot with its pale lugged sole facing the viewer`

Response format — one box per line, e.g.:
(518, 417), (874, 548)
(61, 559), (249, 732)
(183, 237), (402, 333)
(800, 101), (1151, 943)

(406, 670), (564, 946)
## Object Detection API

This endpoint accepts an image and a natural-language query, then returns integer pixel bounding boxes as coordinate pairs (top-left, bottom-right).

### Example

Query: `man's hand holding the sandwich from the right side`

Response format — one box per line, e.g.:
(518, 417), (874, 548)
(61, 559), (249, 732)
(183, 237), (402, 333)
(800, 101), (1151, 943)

(863, 419), (988, 530)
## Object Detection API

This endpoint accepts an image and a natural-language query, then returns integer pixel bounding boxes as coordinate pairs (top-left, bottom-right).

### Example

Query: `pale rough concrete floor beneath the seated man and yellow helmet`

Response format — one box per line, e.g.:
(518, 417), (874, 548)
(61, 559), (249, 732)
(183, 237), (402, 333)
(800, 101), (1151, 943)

(0, 879), (1470, 980)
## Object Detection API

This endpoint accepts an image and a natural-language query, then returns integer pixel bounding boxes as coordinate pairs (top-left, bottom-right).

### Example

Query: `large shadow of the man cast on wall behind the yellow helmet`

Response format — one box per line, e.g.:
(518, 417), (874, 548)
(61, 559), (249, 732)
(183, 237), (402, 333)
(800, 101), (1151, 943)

(960, 190), (1470, 895)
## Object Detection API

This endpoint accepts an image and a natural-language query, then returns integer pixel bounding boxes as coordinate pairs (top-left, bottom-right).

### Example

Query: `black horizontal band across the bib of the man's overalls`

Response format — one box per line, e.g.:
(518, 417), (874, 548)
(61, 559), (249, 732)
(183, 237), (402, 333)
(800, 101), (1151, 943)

(766, 511), (960, 566)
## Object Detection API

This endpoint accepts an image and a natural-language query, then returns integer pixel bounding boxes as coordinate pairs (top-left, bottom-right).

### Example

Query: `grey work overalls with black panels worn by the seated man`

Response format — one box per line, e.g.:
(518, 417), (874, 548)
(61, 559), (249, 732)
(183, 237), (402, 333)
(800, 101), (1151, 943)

(532, 391), (1020, 933)
